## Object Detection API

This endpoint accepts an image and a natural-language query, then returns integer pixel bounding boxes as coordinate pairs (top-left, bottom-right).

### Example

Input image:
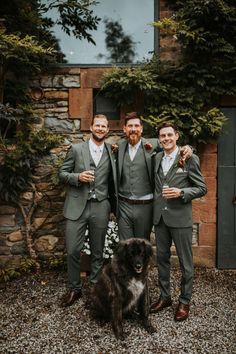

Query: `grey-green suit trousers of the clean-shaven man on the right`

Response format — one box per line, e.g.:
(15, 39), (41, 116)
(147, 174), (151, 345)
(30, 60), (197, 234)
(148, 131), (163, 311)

(155, 218), (194, 304)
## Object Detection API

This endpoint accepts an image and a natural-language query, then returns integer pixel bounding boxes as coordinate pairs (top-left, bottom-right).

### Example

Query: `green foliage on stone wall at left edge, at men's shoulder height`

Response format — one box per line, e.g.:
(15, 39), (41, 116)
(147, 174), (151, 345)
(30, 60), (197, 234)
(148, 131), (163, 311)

(0, 125), (62, 203)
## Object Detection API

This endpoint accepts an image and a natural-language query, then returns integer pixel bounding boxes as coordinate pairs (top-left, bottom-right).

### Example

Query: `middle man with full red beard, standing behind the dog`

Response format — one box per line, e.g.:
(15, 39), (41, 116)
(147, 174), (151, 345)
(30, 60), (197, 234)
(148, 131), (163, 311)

(117, 112), (192, 240)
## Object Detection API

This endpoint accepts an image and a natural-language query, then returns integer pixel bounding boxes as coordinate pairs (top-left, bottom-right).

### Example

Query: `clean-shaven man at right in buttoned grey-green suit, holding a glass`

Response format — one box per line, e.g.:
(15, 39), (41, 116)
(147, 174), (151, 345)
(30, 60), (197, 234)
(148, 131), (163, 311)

(150, 122), (207, 321)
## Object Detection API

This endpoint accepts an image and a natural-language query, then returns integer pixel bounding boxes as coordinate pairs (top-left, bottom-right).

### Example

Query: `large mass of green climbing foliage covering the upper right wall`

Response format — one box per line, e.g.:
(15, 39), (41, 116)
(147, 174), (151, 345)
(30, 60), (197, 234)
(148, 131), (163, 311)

(102, 0), (236, 144)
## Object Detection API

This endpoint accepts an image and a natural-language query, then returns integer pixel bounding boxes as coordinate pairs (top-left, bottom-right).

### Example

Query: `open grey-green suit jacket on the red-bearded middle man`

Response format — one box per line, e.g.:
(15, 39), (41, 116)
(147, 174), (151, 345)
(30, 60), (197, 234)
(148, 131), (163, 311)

(117, 138), (162, 188)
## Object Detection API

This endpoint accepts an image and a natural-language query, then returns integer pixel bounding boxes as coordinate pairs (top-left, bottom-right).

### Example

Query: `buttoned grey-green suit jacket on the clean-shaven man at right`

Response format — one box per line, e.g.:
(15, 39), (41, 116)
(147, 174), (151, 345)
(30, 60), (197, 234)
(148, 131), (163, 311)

(153, 152), (207, 227)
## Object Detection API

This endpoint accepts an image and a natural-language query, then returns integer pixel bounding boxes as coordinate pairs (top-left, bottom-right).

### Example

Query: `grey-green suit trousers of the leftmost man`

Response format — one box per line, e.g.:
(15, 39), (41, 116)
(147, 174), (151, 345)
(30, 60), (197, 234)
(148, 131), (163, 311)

(66, 199), (110, 291)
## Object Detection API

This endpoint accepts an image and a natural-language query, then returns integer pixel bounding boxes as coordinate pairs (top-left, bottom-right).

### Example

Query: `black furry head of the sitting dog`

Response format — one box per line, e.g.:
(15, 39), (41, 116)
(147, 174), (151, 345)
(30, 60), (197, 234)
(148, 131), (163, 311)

(117, 238), (152, 275)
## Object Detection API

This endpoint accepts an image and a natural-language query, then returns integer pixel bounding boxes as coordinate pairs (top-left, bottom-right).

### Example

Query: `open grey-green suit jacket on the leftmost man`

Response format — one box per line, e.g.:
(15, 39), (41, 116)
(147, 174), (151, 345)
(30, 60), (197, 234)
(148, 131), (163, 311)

(59, 141), (117, 220)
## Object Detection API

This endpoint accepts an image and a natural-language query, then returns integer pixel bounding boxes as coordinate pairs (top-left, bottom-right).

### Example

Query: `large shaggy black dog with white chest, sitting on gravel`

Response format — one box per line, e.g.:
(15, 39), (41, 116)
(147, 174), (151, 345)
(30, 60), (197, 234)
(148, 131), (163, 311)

(91, 238), (155, 339)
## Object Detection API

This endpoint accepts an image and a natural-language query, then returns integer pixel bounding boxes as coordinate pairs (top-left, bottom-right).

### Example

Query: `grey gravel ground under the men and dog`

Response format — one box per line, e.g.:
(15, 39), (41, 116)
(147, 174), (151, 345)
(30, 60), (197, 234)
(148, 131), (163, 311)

(0, 267), (236, 354)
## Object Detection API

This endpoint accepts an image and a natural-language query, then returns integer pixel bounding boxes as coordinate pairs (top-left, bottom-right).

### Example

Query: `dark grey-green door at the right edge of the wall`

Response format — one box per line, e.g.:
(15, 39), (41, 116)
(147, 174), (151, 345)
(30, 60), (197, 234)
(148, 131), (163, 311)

(217, 107), (236, 269)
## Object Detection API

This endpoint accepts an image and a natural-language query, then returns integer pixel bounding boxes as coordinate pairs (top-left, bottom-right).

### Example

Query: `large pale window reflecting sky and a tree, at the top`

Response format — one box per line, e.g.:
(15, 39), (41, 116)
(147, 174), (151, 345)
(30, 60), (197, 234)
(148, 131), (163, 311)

(47, 0), (157, 65)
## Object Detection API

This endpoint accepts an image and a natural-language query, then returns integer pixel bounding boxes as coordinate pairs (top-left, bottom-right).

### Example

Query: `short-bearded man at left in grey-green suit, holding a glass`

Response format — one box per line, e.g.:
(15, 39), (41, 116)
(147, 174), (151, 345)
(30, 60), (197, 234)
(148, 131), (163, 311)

(59, 115), (117, 307)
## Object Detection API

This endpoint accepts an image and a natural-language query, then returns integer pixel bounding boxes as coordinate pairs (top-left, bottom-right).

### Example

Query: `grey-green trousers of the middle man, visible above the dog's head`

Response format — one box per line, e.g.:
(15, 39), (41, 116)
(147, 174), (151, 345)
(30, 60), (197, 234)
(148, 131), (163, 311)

(118, 200), (153, 240)
